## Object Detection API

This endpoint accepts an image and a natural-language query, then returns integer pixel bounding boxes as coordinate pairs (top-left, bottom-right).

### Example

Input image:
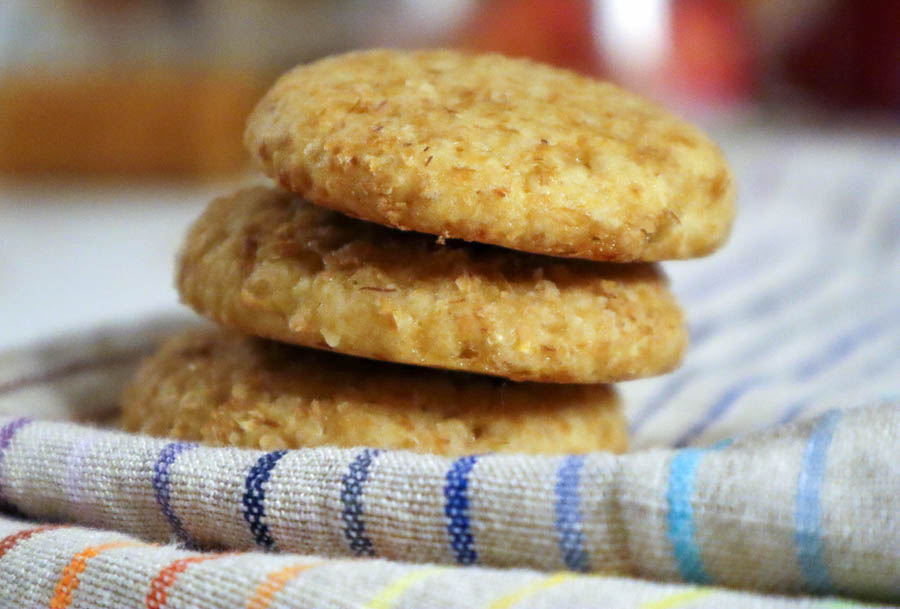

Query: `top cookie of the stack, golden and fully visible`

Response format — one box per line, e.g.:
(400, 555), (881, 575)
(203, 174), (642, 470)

(245, 50), (734, 262)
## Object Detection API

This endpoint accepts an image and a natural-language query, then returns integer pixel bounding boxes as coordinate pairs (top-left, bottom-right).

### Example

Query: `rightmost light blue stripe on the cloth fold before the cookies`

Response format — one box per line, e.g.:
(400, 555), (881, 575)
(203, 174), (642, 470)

(794, 410), (841, 593)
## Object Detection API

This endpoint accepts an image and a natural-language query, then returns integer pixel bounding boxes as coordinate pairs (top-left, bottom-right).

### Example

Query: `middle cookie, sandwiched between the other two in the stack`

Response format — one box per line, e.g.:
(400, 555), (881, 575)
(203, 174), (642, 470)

(177, 187), (686, 383)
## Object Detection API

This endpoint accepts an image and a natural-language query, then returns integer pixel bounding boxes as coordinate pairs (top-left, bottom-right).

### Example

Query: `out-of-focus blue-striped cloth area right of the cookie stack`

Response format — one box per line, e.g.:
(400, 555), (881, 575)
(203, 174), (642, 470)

(621, 128), (900, 449)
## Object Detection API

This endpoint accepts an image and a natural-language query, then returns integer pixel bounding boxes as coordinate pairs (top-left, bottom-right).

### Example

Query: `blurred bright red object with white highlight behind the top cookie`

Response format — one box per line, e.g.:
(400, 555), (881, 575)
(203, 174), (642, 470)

(458, 0), (758, 106)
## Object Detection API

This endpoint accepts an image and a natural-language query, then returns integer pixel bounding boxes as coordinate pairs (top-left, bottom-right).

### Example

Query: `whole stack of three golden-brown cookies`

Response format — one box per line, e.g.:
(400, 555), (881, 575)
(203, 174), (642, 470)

(123, 51), (734, 455)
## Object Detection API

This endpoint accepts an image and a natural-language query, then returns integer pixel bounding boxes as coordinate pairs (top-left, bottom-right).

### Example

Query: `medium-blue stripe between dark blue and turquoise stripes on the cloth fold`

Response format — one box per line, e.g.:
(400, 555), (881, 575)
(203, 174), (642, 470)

(556, 455), (590, 572)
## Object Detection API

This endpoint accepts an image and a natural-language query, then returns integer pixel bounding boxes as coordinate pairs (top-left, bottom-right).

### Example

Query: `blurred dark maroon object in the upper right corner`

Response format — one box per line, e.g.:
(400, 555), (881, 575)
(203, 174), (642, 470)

(784, 0), (900, 110)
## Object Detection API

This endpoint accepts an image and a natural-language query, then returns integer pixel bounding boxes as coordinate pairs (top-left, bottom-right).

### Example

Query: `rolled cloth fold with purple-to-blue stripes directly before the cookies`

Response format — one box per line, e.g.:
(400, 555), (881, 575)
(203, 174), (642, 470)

(0, 404), (900, 600)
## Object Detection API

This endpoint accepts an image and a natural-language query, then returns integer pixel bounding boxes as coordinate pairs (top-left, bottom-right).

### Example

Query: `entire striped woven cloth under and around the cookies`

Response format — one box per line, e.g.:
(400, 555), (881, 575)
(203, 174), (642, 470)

(0, 131), (900, 608)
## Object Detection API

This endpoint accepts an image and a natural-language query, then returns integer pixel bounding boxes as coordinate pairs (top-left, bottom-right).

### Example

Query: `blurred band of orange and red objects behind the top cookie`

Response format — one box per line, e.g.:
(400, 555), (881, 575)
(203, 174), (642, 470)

(0, 0), (900, 177)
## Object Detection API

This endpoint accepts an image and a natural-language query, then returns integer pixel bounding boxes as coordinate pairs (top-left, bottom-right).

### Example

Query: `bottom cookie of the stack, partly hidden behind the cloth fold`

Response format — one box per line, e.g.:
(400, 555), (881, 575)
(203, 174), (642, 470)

(122, 330), (627, 455)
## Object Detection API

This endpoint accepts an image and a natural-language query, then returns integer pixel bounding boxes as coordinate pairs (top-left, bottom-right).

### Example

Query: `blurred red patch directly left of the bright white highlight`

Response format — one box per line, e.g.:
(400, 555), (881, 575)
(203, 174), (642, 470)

(459, 0), (602, 74)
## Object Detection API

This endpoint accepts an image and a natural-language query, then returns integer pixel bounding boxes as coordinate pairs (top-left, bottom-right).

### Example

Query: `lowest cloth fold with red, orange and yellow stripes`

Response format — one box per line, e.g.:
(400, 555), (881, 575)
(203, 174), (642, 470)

(0, 518), (884, 609)
